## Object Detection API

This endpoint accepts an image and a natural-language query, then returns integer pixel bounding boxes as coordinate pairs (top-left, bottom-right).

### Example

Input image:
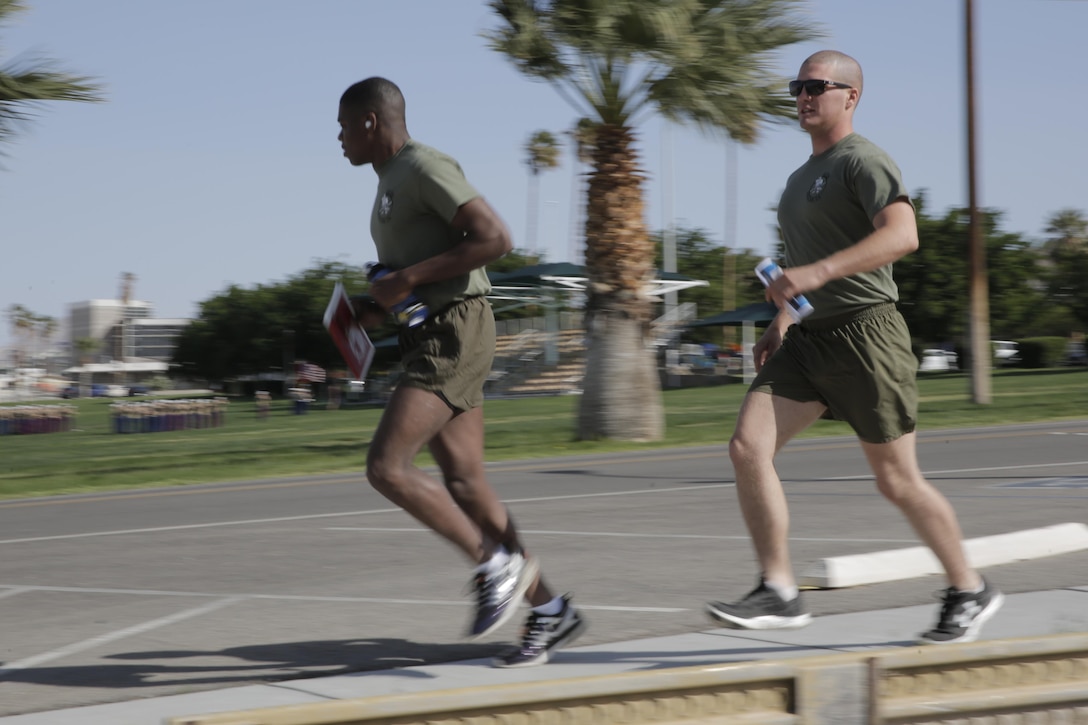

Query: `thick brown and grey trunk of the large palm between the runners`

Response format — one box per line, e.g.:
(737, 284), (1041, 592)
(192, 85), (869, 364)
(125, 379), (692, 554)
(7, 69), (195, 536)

(578, 124), (665, 441)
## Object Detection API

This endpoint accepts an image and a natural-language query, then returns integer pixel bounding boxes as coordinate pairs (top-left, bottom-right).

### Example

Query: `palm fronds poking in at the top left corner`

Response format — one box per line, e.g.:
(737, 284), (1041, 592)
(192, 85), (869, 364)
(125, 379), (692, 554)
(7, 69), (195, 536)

(0, 0), (102, 151)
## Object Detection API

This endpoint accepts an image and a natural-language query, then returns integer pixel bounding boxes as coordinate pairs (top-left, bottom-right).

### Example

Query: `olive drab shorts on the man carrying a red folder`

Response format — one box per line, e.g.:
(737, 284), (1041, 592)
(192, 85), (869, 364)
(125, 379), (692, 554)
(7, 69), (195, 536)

(398, 296), (495, 411)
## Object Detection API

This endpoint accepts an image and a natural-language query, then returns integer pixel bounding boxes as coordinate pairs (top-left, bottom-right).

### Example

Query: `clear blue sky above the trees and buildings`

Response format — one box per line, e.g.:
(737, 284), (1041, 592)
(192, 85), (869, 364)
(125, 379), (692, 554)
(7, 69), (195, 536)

(0, 0), (1088, 346)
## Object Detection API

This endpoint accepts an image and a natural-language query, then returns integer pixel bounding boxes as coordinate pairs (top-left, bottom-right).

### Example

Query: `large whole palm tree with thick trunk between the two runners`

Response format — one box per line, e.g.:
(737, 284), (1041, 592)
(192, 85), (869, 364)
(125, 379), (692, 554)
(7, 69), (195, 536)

(484, 0), (818, 440)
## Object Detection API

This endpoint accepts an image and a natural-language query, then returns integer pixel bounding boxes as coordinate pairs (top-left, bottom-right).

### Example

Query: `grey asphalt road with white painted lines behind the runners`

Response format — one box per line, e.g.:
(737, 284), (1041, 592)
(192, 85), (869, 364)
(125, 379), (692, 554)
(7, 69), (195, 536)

(0, 420), (1088, 715)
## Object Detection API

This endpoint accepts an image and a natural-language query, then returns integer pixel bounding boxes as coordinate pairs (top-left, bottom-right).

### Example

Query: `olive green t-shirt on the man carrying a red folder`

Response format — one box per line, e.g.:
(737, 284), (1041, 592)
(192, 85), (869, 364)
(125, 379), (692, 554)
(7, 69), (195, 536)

(370, 139), (491, 314)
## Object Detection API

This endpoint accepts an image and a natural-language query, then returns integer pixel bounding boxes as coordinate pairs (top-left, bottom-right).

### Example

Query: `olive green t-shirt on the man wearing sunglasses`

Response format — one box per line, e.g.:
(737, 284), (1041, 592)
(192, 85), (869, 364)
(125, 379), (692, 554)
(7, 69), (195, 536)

(778, 134), (911, 320)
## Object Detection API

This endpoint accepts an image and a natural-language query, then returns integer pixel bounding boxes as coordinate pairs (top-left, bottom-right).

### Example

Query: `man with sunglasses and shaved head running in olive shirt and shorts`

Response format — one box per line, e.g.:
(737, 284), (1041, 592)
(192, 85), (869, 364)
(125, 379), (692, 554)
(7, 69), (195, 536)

(707, 50), (1004, 643)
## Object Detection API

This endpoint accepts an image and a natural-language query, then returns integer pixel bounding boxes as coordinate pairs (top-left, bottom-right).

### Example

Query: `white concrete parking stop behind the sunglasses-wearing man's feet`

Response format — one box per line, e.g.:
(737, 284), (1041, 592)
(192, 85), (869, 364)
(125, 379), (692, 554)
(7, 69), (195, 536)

(798, 524), (1088, 589)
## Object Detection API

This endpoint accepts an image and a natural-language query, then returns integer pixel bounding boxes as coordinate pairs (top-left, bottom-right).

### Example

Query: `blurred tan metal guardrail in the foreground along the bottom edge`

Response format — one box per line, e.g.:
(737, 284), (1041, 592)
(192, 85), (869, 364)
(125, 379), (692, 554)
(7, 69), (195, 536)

(164, 634), (1088, 725)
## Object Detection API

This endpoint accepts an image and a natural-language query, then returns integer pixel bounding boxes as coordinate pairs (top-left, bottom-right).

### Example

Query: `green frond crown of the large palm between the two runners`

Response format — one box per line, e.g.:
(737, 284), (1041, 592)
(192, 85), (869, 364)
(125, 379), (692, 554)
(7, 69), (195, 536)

(485, 0), (819, 143)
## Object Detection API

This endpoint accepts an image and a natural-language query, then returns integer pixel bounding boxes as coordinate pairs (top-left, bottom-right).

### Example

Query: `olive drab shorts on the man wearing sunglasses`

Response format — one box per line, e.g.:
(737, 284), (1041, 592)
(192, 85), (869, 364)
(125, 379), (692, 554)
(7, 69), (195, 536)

(749, 303), (918, 443)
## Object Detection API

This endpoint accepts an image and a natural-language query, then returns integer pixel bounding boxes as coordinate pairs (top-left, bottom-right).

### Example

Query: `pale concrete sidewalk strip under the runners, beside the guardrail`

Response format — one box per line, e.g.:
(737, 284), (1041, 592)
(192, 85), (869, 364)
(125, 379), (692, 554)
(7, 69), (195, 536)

(0, 586), (1088, 725)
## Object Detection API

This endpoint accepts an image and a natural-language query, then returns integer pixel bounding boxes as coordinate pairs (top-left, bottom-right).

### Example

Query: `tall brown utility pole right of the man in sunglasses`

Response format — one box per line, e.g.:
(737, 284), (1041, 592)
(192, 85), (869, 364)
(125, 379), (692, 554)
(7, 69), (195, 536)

(964, 0), (992, 405)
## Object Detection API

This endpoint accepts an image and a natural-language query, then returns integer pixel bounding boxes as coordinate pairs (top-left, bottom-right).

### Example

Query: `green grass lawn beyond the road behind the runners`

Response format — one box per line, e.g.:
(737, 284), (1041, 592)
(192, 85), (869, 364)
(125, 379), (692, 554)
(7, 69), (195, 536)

(0, 368), (1088, 499)
